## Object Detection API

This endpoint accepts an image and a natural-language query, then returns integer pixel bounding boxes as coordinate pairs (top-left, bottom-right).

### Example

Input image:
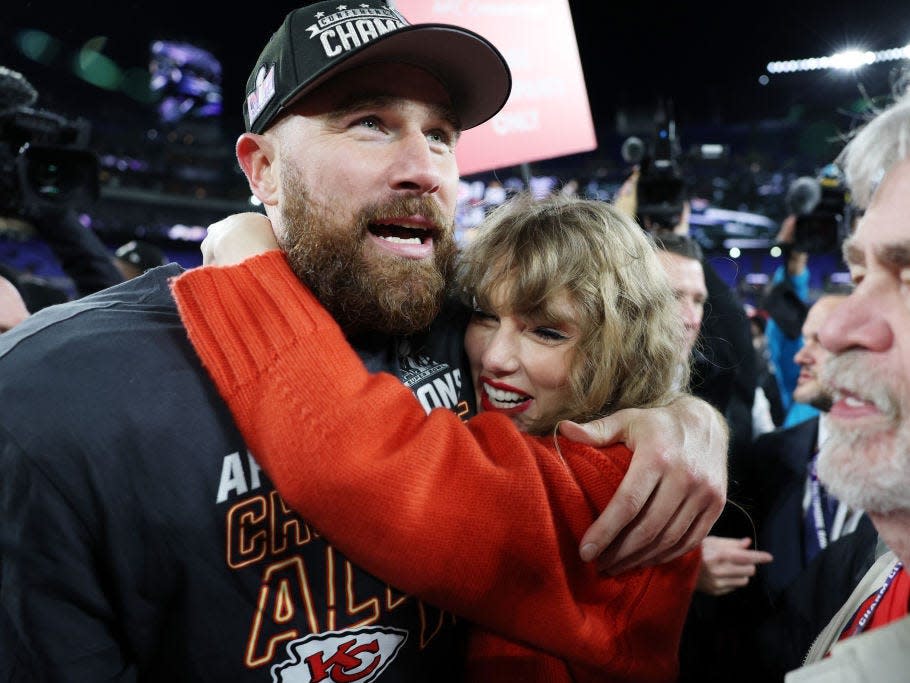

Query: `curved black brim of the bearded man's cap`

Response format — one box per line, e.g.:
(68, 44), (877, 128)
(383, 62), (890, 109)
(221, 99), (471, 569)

(281, 24), (512, 130)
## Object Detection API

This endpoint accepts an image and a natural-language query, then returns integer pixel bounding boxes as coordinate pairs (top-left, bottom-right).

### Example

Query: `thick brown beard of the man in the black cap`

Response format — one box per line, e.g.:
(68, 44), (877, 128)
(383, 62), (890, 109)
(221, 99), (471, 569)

(280, 172), (456, 336)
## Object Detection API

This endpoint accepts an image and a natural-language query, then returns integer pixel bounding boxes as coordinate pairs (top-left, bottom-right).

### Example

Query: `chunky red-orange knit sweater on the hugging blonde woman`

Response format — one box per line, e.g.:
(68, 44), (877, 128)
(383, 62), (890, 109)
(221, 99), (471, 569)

(173, 251), (699, 681)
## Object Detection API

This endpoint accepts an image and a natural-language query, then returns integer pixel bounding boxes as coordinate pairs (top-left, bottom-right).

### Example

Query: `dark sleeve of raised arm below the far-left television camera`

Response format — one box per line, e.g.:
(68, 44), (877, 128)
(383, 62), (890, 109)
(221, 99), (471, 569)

(29, 208), (123, 296)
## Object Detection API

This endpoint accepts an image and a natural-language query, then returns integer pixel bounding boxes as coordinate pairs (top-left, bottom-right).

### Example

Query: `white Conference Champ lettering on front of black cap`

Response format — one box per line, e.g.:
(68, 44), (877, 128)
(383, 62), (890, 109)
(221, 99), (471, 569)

(307, 5), (409, 57)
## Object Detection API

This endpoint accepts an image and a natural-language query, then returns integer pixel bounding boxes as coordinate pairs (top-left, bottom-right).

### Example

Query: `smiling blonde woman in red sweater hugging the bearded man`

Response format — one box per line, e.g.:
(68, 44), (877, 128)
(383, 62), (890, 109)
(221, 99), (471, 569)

(174, 195), (698, 681)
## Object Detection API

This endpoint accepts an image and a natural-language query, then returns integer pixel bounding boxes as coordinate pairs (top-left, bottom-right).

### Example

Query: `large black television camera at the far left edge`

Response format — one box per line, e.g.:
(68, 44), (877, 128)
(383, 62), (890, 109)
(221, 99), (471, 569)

(0, 67), (99, 217)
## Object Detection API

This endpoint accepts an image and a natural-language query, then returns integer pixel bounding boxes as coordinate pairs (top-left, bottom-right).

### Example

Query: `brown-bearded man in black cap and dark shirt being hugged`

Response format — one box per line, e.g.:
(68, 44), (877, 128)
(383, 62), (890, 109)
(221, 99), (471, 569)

(0, 0), (727, 682)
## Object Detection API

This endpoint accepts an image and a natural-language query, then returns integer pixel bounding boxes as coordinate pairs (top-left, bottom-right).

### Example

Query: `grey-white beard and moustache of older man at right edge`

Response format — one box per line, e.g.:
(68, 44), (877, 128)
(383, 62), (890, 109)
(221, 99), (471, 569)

(818, 351), (910, 514)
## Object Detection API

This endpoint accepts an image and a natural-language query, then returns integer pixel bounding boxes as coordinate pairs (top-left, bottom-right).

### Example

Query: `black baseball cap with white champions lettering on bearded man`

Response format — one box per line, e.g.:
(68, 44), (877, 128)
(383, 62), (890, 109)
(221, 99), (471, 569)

(243, 0), (512, 133)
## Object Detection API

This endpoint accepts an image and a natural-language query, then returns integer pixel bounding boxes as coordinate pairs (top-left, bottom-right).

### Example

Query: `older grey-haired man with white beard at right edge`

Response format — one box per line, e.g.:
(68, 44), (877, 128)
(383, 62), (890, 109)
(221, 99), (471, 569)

(785, 79), (910, 683)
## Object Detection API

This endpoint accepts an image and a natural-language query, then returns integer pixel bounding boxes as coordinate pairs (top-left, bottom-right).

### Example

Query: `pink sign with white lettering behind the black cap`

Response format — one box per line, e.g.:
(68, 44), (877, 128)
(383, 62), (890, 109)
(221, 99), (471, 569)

(393, 0), (597, 175)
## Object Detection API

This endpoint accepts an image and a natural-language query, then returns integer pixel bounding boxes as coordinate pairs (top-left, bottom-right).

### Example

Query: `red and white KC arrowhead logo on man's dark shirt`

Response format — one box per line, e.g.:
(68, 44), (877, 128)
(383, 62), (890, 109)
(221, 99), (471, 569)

(272, 626), (408, 683)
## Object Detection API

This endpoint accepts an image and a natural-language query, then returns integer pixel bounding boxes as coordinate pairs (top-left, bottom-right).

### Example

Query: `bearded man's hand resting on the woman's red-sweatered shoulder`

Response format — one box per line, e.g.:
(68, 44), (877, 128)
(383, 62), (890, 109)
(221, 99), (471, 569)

(559, 396), (729, 574)
